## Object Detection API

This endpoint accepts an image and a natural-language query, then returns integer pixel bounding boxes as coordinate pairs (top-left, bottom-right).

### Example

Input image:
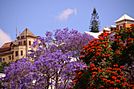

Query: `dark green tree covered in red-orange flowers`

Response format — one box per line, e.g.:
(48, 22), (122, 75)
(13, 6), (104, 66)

(73, 27), (134, 89)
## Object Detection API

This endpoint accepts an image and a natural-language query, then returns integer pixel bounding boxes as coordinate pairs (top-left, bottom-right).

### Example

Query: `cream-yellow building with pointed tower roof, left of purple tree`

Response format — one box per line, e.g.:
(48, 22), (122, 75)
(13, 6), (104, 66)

(0, 28), (37, 63)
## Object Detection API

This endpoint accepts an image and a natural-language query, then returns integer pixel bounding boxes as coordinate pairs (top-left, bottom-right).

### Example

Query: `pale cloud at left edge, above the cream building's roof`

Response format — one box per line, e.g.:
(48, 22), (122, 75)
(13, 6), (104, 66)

(0, 29), (12, 47)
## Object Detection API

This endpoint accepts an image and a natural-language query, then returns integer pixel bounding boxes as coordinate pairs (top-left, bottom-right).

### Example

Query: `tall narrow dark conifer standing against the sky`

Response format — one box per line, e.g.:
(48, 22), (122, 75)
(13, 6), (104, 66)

(89, 8), (99, 32)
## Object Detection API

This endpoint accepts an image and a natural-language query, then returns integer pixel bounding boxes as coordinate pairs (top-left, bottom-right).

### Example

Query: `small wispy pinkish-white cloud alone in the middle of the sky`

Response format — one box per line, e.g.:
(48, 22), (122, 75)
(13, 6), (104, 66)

(57, 8), (77, 21)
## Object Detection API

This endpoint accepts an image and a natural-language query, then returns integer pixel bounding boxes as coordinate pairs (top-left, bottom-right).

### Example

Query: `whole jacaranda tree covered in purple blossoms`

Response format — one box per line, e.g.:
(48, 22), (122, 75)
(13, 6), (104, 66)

(3, 28), (93, 89)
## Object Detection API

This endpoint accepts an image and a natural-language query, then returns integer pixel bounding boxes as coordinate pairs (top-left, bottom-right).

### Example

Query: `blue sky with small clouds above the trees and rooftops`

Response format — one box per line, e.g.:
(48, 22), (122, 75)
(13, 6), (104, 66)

(0, 0), (134, 44)
